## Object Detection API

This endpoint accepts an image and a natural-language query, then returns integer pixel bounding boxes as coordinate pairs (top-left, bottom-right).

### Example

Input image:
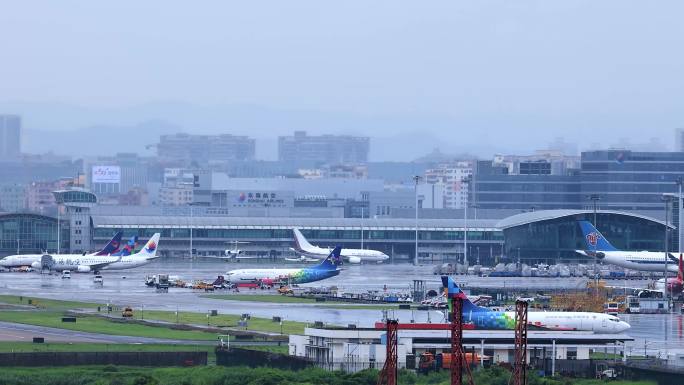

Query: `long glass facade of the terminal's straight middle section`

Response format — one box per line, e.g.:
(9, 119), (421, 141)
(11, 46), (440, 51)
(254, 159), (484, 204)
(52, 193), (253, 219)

(93, 225), (503, 263)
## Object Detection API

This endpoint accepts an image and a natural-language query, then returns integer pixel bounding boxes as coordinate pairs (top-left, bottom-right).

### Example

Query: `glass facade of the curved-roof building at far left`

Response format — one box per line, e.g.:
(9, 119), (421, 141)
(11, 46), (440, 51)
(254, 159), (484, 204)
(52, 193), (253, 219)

(0, 214), (69, 256)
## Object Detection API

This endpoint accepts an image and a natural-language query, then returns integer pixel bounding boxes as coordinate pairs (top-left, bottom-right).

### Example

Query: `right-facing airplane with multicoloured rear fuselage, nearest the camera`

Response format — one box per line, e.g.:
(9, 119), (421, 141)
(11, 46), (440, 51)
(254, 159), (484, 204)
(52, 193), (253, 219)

(442, 276), (630, 334)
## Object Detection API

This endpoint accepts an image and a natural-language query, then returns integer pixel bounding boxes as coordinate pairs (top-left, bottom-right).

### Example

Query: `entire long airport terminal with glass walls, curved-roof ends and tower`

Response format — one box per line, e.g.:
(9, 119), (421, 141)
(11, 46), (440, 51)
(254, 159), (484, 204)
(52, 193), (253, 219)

(0, 191), (677, 266)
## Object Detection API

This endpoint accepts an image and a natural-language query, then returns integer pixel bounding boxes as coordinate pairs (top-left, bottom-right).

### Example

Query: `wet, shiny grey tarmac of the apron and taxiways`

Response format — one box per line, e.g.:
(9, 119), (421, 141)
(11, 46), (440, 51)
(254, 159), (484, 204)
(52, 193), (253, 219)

(0, 260), (684, 355)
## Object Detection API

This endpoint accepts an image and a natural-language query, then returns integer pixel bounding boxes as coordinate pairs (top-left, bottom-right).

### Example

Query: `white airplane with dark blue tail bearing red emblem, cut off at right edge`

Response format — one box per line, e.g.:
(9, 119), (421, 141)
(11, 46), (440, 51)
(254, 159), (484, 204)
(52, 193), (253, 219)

(575, 221), (679, 273)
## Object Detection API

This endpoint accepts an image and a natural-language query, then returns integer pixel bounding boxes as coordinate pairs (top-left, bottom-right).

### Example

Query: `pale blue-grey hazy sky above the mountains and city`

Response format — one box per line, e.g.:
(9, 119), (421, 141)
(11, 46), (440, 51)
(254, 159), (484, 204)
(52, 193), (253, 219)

(0, 0), (684, 158)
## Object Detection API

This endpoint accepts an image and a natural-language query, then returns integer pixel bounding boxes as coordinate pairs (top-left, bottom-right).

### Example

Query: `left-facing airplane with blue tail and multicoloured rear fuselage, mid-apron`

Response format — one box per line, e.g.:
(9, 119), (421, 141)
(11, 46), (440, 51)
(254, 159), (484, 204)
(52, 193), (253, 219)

(224, 246), (342, 285)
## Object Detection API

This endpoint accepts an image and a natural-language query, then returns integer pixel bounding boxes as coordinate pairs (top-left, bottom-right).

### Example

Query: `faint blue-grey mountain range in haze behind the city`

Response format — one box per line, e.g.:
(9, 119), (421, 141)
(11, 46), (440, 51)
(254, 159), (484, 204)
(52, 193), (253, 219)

(0, 102), (534, 161)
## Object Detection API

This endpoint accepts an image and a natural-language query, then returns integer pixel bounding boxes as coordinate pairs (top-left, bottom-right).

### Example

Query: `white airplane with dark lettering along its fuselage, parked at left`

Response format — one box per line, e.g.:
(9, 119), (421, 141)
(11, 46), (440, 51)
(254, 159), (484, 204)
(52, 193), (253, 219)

(38, 233), (160, 273)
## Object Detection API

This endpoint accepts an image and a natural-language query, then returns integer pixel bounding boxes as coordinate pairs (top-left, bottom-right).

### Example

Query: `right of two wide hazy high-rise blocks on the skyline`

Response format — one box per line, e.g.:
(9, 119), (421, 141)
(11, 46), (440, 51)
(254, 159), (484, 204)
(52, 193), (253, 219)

(278, 131), (370, 164)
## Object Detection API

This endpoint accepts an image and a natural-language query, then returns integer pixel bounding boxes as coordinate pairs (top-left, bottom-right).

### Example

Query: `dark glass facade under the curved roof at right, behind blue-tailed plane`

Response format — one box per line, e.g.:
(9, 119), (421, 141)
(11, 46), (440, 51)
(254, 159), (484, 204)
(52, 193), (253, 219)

(503, 213), (672, 264)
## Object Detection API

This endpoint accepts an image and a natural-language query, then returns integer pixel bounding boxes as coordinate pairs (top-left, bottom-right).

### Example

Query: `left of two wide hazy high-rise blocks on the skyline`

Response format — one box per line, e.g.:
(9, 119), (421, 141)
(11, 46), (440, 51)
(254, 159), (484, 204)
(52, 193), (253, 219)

(157, 134), (256, 164)
